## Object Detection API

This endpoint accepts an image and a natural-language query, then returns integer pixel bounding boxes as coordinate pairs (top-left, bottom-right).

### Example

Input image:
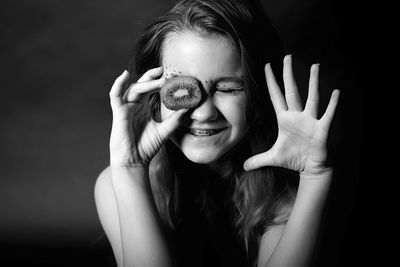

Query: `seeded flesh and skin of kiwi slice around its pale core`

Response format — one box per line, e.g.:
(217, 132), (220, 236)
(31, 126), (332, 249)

(160, 76), (201, 110)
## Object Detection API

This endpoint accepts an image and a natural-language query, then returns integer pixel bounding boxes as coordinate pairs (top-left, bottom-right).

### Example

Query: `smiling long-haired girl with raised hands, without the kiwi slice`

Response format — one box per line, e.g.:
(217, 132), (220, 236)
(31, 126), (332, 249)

(95, 0), (339, 267)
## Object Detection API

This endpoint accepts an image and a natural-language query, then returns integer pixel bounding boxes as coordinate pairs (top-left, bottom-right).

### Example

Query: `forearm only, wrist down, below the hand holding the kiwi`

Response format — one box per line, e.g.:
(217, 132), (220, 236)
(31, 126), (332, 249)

(111, 166), (171, 267)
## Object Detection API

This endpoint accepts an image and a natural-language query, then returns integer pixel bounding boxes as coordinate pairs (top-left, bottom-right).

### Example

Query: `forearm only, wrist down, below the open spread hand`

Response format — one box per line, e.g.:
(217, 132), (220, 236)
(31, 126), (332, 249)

(265, 169), (332, 267)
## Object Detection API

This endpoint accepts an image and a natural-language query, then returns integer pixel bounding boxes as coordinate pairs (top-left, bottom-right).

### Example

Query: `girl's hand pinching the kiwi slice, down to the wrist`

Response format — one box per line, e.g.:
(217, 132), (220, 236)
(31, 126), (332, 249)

(110, 67), (187, 167)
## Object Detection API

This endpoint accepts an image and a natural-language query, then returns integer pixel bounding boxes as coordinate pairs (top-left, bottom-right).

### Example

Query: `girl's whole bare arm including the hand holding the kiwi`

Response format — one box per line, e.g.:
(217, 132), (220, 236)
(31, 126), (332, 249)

(95, 68), (185, 267)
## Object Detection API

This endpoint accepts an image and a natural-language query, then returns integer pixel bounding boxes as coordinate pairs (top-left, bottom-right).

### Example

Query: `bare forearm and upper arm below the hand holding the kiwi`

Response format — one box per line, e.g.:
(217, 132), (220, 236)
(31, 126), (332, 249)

(95, 167), (171, 267)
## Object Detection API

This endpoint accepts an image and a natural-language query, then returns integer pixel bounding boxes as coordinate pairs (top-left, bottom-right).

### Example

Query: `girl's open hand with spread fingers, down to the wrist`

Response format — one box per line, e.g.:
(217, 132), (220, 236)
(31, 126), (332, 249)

(243, 55), (339, 177)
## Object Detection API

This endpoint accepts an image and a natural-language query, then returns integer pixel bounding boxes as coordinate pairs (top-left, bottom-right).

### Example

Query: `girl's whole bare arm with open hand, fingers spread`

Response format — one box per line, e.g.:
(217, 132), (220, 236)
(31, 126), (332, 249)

(244, 56), (339, 267)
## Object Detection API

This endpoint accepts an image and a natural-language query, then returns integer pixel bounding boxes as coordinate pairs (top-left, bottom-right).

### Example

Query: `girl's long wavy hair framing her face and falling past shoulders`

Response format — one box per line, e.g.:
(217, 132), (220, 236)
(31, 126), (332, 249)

(127, 0), (295, 264)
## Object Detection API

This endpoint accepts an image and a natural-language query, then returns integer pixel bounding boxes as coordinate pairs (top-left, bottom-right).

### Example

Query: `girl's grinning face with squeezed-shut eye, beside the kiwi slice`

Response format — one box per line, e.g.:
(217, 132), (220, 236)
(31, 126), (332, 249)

(161, 31), (246, 164)
